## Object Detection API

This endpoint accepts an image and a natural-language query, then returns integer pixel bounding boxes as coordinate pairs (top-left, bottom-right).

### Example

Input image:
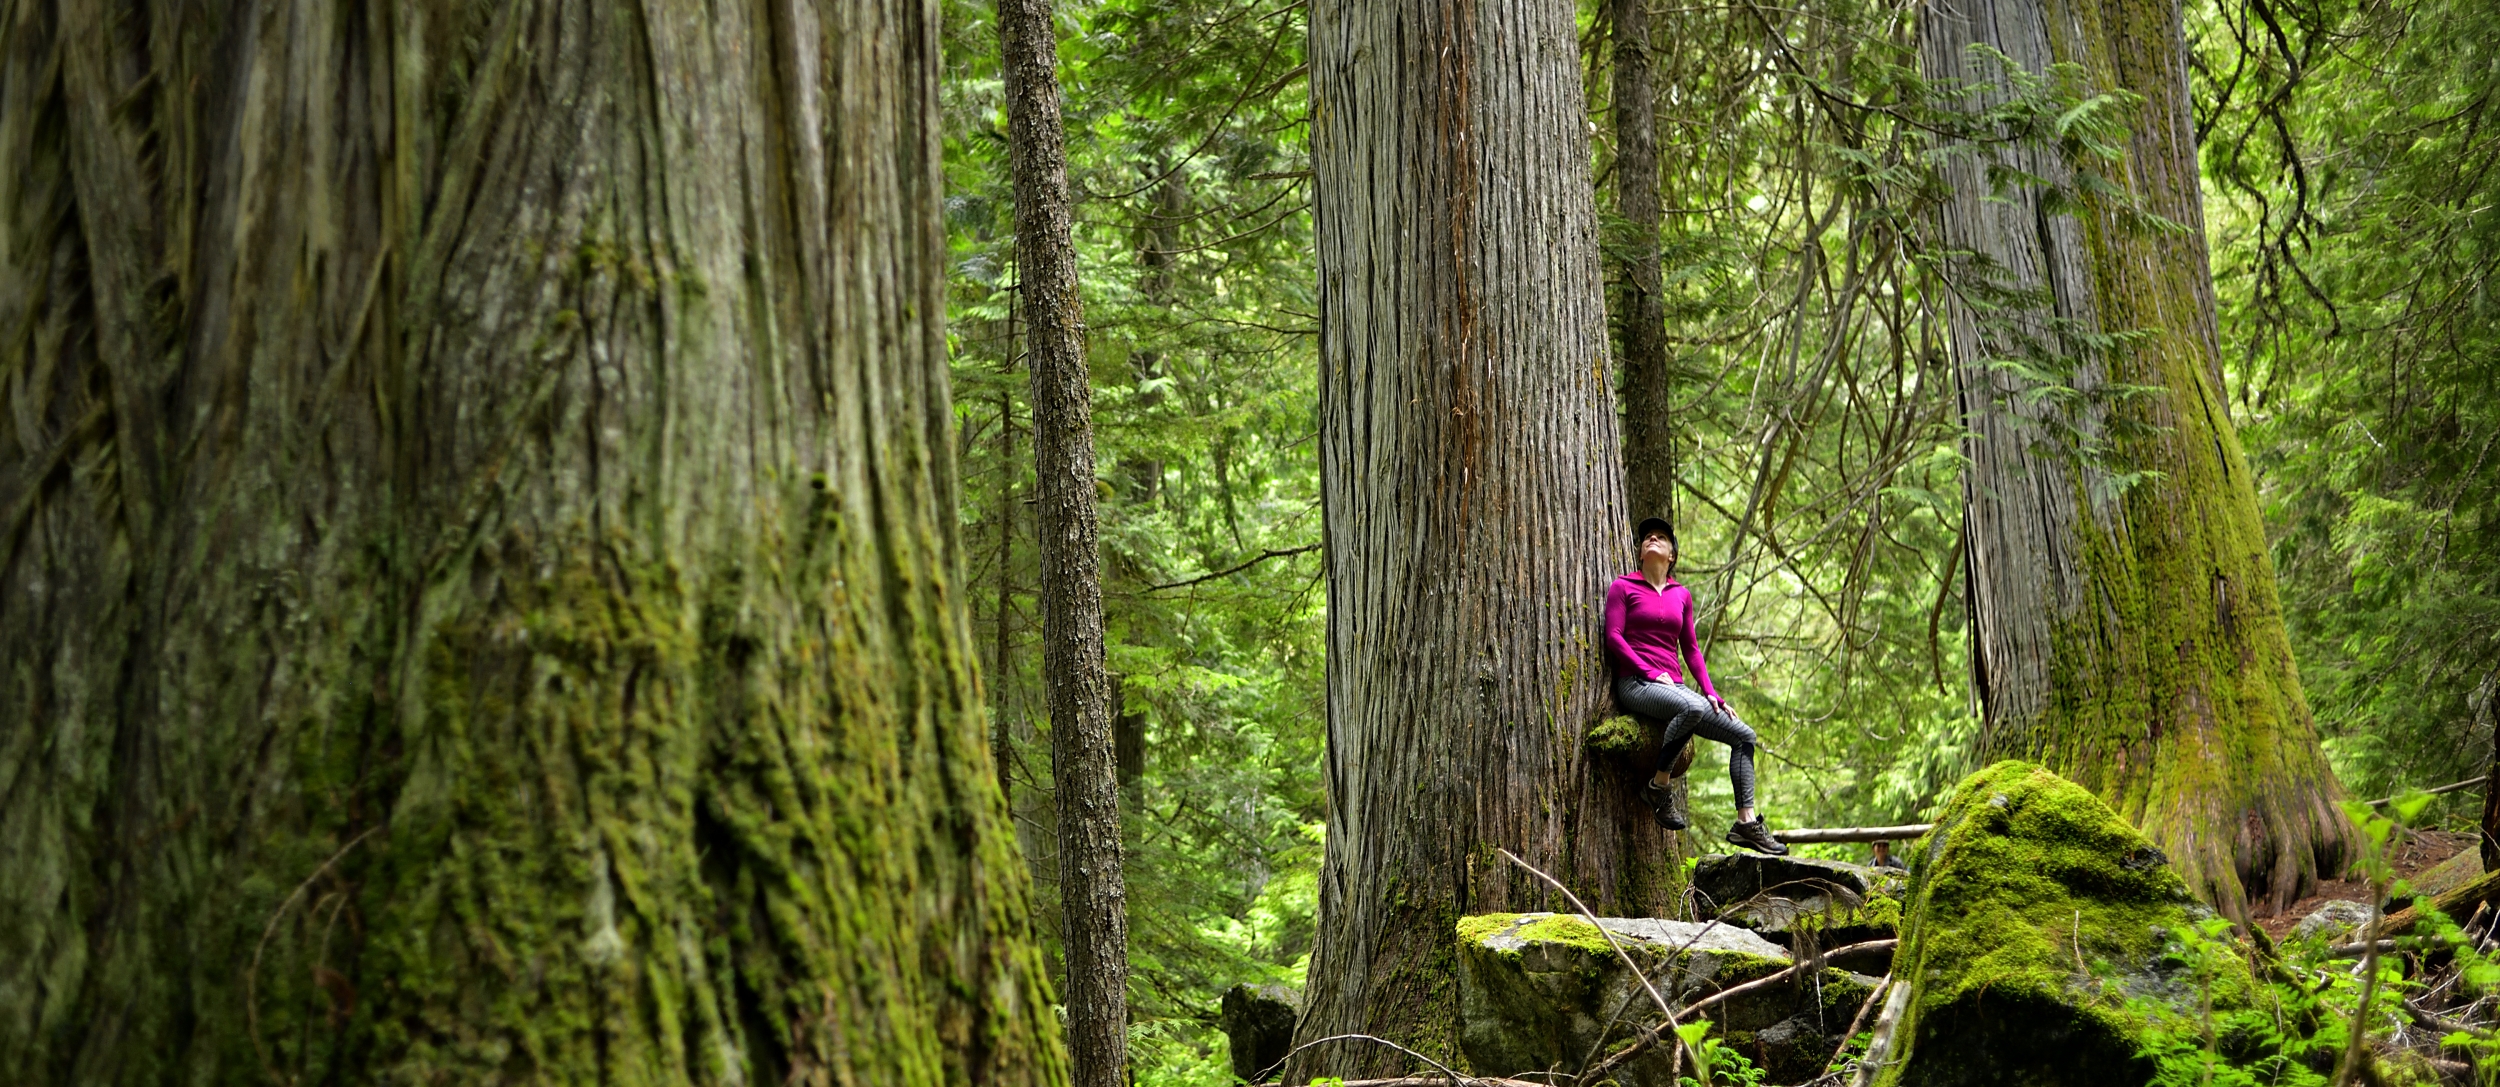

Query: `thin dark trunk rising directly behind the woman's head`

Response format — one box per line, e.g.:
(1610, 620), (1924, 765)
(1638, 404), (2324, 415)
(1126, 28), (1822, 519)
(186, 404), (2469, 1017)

(1610, 0), (1675, 520)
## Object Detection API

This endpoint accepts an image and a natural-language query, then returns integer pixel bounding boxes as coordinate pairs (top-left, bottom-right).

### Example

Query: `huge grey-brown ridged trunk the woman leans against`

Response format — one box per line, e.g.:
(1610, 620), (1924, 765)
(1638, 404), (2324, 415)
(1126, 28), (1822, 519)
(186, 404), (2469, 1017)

(1300, 0), (1670, 1075)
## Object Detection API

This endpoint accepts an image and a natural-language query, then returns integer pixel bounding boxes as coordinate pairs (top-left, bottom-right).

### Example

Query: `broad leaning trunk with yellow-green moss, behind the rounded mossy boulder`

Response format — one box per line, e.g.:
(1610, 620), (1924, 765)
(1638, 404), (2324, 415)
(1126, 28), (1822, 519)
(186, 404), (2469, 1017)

(1920, 0), (2353, 915)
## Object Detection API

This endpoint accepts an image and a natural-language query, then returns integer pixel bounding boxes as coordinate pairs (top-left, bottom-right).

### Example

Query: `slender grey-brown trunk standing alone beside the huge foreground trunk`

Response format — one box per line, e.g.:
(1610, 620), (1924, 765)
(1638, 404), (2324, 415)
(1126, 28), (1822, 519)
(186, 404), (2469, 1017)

(998, 0), (1128, 1087)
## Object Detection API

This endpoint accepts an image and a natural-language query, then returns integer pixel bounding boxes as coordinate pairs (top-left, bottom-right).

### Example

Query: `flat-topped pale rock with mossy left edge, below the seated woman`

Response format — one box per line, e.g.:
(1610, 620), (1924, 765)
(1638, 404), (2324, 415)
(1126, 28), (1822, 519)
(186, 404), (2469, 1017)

(1458, 915), (1875, 1087)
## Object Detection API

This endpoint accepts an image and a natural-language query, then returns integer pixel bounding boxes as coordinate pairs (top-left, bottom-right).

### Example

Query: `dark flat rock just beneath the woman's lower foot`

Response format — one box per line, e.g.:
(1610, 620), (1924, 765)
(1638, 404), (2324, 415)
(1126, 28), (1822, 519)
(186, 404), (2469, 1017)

(1693, 852), (1910, 954)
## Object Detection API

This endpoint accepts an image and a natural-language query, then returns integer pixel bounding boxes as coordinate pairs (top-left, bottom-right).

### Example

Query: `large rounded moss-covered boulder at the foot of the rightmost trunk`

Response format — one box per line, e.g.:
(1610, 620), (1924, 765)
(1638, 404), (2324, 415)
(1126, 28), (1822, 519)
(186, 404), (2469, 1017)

(1870, 762), (2255, 1087)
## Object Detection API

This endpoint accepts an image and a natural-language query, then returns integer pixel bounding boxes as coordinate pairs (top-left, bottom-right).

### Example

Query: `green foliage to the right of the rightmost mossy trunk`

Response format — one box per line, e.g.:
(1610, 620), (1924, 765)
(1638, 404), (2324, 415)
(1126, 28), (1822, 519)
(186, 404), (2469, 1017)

(2190, 0), (2500, 820)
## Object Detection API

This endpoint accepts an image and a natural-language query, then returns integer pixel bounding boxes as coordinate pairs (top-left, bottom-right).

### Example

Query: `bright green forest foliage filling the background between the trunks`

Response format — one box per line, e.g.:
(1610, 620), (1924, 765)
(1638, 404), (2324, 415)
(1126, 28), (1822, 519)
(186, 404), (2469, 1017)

(940, 0), (2500, 1085)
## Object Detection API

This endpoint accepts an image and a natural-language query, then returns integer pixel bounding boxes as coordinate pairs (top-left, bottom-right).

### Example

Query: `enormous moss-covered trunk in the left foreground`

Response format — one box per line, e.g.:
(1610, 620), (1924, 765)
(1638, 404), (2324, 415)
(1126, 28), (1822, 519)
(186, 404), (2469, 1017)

(0, 0), (1065, 1085)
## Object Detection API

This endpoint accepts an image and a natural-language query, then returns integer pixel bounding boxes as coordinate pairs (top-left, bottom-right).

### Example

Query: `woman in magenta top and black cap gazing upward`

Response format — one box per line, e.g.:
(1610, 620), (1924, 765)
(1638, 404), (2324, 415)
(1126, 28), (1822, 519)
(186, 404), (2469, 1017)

(1605, 517), (1788, 857)
